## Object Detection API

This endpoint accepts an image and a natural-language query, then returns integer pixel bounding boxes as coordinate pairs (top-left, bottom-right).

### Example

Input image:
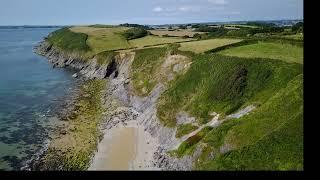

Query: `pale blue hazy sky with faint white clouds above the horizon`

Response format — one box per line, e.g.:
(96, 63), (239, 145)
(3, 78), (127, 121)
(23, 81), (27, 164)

(0, 0), (303, 25)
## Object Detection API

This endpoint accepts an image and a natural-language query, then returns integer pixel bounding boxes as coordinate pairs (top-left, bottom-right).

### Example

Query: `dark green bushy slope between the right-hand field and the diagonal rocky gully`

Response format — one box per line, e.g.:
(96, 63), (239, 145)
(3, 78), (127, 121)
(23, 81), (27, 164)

(157, 54), (302, 127)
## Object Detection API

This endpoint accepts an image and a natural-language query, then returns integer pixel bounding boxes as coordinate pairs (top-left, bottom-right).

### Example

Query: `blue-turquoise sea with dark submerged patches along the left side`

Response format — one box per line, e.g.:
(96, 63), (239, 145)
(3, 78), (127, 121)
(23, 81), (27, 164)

(0, 27), (76, 170)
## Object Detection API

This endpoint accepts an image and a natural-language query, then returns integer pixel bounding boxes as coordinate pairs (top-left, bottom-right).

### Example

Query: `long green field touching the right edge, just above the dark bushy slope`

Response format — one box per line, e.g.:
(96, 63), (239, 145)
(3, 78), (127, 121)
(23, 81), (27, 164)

(219, 42), (303, 64)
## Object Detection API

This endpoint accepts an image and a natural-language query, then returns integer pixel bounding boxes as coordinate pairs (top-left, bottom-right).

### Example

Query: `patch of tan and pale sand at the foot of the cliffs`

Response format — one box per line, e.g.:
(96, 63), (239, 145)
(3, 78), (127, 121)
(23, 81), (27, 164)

(88, 121), (156, 170)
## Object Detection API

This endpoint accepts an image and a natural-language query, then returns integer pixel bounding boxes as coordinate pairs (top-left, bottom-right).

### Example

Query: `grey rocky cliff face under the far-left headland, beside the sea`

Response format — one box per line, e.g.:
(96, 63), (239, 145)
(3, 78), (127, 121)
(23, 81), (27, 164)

(34, 41), (118, 79)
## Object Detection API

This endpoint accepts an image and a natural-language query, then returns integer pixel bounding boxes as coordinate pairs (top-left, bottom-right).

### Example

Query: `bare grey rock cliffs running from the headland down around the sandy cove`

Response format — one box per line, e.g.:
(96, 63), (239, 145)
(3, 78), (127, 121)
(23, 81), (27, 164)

(31, 41), (199, 170)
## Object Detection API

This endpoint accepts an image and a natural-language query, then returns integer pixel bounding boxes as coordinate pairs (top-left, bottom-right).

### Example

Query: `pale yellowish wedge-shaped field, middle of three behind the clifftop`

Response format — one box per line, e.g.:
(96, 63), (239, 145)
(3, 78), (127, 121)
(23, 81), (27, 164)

(179, 39), (241, 53)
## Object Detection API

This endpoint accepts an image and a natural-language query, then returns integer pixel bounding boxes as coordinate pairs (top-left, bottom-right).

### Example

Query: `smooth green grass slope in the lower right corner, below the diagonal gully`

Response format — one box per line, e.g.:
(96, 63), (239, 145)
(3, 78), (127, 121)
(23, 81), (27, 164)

(196, 75), (303, 170)
